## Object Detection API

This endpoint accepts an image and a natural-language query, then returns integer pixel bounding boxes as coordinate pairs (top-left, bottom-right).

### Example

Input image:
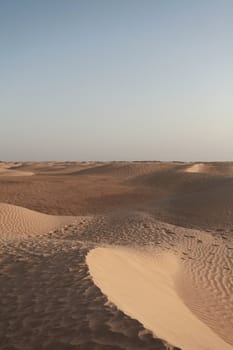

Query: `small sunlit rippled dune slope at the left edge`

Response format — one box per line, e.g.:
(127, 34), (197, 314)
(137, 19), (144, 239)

(0, 203), (72, 238)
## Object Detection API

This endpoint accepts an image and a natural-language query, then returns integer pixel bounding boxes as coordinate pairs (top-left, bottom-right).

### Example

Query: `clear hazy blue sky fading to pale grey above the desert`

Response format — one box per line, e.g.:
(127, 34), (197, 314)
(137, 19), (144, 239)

(0, 0), (233, 160)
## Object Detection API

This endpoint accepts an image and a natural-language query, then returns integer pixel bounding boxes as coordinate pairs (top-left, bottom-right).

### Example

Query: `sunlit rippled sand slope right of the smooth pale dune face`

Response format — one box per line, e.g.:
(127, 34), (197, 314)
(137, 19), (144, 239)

(177, 235), (233, 345)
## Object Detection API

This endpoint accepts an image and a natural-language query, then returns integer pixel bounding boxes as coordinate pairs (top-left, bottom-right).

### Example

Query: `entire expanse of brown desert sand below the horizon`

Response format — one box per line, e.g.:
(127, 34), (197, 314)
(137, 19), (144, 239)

(0, 162), (233, 350)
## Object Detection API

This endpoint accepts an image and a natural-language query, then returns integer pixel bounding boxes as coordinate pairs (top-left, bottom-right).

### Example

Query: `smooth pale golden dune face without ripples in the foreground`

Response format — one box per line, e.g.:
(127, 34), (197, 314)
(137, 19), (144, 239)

(87, 247), (232, 350)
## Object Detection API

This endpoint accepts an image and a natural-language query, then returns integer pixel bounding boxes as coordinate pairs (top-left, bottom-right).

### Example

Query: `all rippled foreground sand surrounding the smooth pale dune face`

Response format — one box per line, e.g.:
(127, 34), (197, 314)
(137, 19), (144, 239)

(0, 204), (233, 350)
